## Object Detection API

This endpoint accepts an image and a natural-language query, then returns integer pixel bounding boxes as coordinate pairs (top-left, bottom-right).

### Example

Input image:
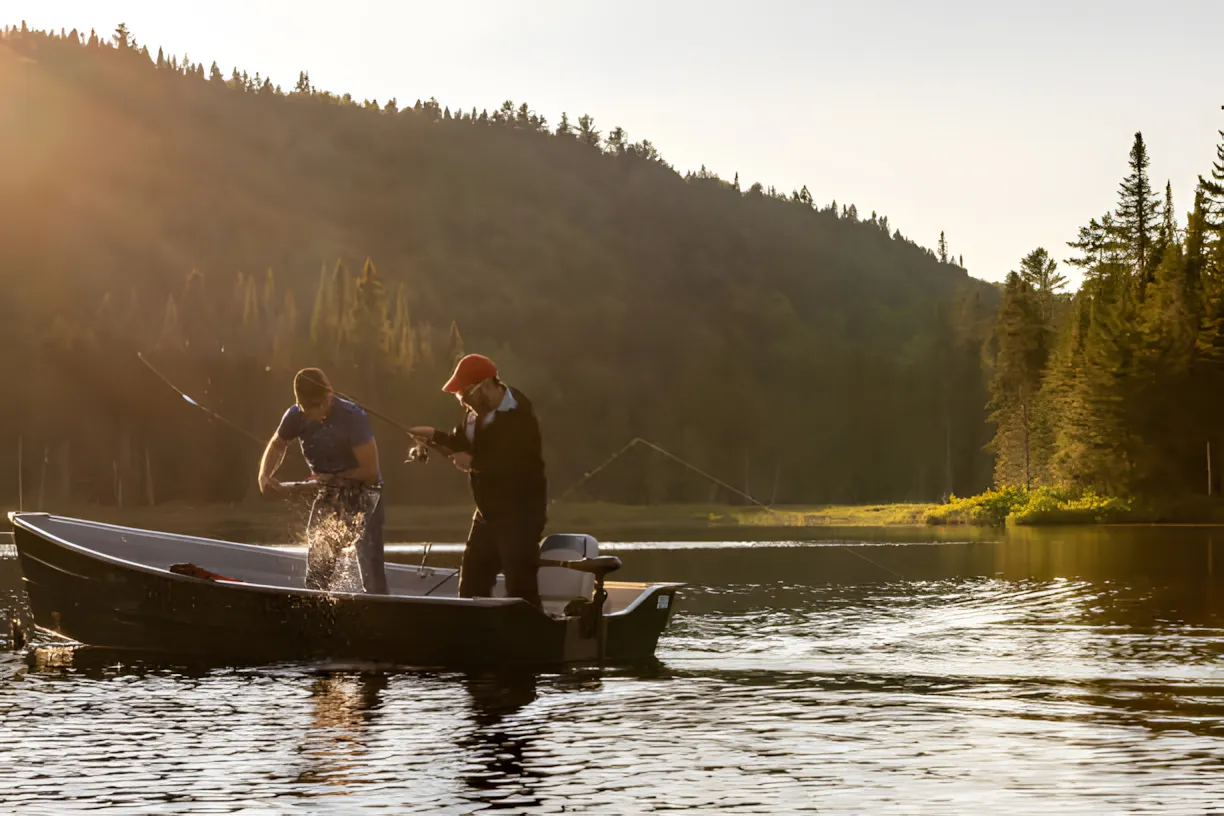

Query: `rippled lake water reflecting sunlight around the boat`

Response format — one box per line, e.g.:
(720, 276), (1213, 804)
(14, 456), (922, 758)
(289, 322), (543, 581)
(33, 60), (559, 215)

(0, 527), (1224, 814)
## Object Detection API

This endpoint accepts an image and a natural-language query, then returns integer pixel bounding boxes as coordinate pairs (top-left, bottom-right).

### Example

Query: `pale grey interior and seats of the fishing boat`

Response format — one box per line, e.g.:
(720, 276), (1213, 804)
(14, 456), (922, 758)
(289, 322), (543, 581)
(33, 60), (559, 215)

(10, 513), (650, 615)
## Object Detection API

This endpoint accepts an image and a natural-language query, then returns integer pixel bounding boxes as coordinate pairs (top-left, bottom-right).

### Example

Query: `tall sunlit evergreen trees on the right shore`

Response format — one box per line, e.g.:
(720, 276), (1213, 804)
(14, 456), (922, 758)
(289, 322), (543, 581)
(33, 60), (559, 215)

(988, 122), (1224, 495)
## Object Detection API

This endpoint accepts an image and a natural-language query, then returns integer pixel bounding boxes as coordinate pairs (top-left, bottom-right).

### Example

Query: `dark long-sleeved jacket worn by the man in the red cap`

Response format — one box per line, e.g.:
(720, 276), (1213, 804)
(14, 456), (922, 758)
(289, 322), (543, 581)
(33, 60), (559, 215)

(435, 385), (548, 522)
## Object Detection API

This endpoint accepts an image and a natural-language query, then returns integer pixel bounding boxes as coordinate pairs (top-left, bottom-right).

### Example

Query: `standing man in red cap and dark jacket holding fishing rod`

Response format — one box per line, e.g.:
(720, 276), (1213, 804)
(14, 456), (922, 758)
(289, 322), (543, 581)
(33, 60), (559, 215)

(411, 355), (547, 607)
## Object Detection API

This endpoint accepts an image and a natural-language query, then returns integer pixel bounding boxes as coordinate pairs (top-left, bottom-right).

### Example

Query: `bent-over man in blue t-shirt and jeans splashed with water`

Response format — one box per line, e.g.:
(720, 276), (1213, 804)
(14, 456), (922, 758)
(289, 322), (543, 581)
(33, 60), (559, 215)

(259, 368), (387, 595)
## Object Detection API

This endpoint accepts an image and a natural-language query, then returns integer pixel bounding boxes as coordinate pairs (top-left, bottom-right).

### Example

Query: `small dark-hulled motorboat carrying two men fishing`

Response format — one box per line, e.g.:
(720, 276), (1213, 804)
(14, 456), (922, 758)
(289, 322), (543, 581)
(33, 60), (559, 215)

(9, 513), (683, 668)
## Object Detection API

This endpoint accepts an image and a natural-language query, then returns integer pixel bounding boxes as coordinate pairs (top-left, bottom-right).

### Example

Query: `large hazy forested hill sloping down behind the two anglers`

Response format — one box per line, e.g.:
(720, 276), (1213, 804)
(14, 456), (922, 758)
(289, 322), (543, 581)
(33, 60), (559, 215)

(0, 27), (998, 511)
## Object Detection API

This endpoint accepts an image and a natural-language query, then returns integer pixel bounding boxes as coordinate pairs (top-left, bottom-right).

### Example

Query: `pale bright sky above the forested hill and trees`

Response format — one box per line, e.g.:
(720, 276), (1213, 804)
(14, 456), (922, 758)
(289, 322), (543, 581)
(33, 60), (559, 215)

(9, 0), (1224, 286)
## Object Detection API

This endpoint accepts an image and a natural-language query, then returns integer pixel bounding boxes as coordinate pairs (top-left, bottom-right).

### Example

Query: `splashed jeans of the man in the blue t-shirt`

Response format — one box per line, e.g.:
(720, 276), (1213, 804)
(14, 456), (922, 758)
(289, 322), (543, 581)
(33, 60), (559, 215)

(306, 487), (387, 595)
